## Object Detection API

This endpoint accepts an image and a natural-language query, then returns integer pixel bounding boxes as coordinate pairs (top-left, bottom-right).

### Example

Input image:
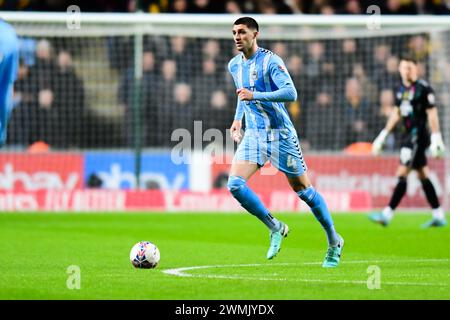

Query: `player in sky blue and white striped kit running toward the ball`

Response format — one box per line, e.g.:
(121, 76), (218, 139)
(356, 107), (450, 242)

(228, 17), (344, 267)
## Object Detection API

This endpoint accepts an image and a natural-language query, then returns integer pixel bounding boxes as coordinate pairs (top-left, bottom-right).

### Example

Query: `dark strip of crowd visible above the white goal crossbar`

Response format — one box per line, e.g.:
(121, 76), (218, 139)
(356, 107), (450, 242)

(0, 0), (450, 15)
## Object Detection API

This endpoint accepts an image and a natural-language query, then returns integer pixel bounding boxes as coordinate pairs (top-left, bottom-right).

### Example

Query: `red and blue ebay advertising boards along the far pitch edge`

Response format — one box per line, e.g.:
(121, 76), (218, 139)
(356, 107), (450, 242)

(0, 152), (450, 212)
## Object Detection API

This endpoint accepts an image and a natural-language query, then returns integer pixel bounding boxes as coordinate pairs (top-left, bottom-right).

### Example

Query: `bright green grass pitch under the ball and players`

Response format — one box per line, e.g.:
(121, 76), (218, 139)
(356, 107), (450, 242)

(0, 213), (450, 300)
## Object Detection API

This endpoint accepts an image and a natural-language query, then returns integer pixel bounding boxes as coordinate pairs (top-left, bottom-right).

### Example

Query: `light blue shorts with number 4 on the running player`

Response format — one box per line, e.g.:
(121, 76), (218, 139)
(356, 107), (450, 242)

(233, 134), (308, 177)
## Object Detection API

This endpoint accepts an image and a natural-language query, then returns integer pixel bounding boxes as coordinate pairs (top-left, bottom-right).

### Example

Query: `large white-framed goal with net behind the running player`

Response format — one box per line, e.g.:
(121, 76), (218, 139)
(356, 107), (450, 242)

(0, 12), (450, 211)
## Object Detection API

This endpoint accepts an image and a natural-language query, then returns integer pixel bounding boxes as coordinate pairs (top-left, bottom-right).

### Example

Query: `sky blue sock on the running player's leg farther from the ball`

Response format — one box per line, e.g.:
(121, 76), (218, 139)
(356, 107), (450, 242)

(297, 186), (339, 246)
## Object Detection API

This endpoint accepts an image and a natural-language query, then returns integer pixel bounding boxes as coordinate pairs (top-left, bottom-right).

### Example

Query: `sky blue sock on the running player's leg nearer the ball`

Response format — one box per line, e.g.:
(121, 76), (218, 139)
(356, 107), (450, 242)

(228, 176), (281, 231)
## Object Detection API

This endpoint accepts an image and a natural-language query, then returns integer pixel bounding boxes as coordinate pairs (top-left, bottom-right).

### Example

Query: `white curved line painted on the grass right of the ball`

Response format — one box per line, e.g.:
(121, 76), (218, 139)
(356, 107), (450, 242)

(161, 259), (450, 287)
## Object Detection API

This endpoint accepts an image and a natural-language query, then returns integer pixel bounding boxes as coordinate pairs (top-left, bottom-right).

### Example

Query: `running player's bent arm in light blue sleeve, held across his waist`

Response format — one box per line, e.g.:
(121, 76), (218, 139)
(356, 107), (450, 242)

(236, 56), (297, 102)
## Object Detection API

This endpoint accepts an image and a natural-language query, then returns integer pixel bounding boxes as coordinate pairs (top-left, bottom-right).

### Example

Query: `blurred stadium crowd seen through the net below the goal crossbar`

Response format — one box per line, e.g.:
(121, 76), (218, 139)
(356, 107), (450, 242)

(9, 29), (450, 150)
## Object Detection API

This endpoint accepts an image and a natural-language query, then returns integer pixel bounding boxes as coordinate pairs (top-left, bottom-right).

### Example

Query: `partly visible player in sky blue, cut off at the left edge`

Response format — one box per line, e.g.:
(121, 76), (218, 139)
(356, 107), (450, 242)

(0, 19), (19, 147)
